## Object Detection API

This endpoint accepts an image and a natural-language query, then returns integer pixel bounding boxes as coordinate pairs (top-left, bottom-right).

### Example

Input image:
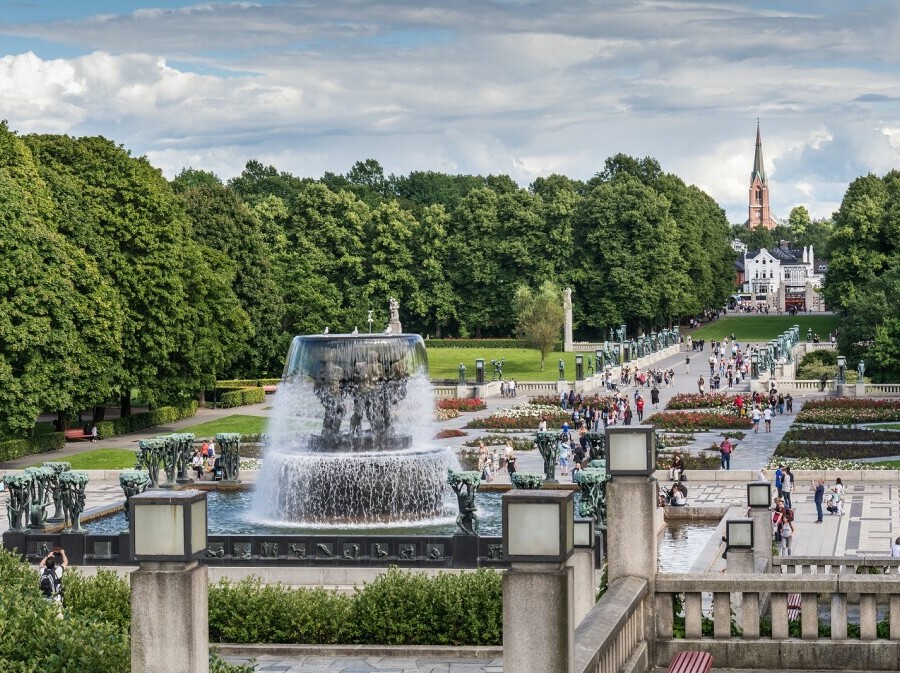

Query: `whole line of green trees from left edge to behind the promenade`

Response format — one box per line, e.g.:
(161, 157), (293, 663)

(0, 123), (734, 435)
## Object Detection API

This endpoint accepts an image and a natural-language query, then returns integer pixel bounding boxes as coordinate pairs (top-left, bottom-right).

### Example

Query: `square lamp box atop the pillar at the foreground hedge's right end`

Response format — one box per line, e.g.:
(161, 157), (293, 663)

(503, 490), (575, 565)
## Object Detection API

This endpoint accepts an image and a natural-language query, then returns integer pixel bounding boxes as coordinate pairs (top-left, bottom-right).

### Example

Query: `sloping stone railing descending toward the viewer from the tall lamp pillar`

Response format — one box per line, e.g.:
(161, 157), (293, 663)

(574, 577), (650, 673)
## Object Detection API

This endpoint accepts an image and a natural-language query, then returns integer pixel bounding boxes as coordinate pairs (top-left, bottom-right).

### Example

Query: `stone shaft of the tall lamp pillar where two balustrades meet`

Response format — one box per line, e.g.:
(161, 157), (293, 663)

(600, 475), (659, 652)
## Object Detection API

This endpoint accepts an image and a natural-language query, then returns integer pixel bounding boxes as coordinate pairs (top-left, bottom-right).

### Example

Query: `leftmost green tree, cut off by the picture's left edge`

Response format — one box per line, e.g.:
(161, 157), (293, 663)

(0, 122), (122, 435)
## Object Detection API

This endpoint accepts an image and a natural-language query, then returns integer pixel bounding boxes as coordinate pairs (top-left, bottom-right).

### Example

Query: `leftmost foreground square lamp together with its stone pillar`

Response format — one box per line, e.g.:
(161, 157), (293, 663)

(129, 491), (209, 673)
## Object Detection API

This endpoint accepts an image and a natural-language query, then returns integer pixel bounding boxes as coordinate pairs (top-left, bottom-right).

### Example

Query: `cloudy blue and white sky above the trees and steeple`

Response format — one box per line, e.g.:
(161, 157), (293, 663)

(0, 0), (900, 222)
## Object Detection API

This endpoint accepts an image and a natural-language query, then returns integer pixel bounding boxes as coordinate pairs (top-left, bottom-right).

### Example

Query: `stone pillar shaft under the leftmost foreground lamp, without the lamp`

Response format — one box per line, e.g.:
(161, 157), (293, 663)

(131, 561), (209, 673)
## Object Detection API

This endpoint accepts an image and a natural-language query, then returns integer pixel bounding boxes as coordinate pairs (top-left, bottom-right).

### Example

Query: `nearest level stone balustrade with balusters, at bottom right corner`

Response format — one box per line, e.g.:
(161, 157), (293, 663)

(652, 572), (900, 670)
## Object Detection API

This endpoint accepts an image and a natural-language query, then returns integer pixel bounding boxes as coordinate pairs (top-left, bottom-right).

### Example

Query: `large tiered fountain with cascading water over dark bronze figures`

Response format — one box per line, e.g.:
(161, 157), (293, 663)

(253, 330), (451, 526)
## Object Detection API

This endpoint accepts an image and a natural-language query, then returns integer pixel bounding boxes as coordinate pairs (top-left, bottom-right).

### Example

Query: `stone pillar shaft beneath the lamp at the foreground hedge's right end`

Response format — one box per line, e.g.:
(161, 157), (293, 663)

(503, 563), (576, 673)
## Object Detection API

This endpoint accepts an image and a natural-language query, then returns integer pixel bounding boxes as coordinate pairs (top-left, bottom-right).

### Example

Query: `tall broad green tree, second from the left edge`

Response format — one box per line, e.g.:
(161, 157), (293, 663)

(25, 135), (232, 417)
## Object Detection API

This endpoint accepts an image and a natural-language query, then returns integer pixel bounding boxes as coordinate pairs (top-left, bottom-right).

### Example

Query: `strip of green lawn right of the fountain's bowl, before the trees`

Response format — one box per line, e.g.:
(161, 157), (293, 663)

(426, 350), (593, 381)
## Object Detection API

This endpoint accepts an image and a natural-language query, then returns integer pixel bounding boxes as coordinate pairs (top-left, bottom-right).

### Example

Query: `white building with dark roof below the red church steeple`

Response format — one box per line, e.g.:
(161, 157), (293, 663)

(736, 241), (828, 311)
